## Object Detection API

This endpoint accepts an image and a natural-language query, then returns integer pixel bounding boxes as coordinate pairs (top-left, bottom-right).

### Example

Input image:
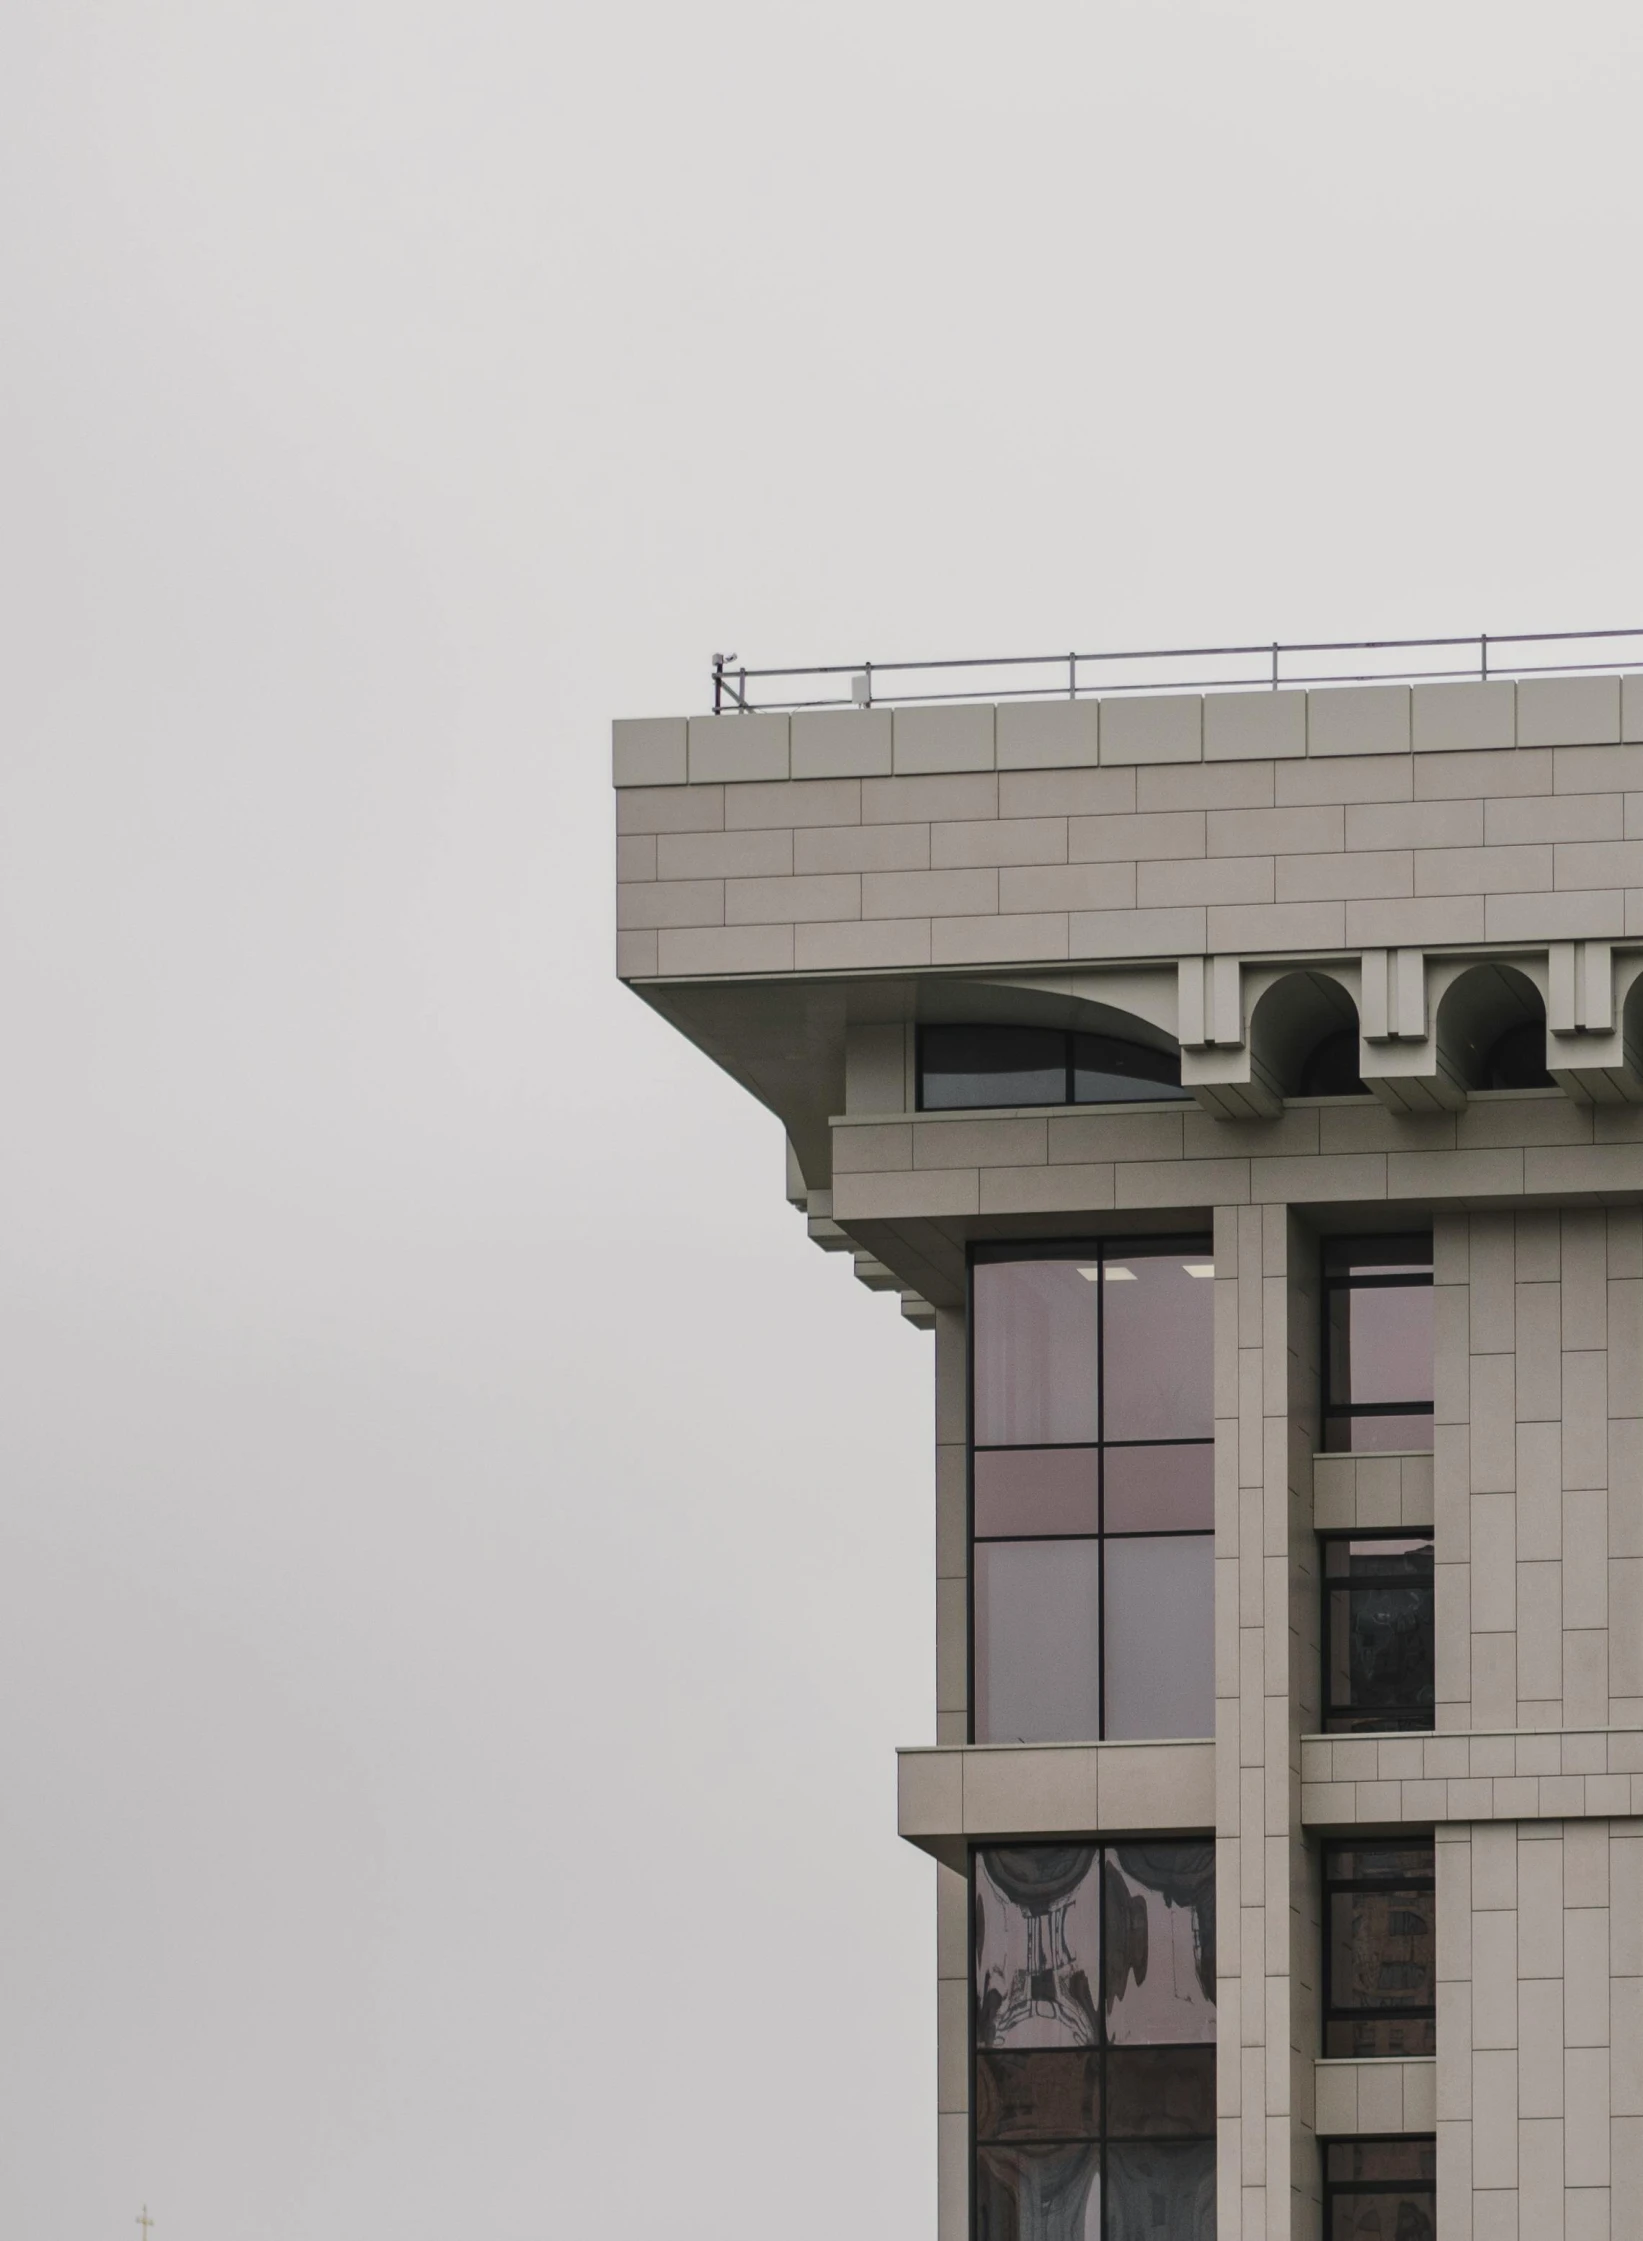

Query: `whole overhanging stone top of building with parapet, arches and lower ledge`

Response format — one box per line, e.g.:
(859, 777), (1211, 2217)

(614, 675), (1643, 1307)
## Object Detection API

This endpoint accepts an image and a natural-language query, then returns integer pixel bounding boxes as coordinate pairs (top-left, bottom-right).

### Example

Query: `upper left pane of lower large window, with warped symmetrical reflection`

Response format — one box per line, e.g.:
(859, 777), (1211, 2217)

(975, 1844), (1101, 2048)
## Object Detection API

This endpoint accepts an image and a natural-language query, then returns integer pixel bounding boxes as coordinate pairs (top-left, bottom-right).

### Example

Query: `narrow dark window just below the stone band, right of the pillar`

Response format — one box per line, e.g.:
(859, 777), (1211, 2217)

(1322, 1838), (1437, 2062)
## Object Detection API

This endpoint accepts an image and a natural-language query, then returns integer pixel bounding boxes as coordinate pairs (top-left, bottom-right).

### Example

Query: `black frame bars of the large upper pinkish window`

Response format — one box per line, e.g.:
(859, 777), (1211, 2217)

(964, 1230), (1215, 1743)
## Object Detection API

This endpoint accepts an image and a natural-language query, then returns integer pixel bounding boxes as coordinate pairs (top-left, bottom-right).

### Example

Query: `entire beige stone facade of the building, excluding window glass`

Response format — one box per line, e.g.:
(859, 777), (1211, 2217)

(614, 677), (1643, 2241)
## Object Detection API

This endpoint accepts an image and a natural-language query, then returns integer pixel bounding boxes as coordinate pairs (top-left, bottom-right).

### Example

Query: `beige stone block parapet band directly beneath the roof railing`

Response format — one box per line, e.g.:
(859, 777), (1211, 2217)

(614, 677), (1643, 979)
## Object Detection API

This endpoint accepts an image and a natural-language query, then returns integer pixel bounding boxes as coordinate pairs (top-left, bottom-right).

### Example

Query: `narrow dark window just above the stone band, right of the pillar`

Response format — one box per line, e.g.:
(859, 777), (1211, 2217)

(1322, 1533), (1437, 1735)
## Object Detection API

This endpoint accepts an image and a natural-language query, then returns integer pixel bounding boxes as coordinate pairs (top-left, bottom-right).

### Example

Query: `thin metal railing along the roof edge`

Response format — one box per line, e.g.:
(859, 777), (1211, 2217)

(713, 627), (1643, 715)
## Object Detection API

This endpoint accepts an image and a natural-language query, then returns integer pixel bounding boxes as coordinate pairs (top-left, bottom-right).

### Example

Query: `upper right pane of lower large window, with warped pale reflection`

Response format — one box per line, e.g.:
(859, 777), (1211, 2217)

(1103, 1844), (1215, 2046)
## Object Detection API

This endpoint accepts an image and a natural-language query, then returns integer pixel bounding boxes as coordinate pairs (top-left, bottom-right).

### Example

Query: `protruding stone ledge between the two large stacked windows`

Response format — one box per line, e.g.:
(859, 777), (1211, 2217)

(897, 1741), (1215, 1869)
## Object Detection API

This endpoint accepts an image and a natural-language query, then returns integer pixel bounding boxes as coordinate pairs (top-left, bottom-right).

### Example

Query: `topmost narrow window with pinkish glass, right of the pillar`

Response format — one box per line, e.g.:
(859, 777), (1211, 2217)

(1322, 1235), (1432, 1454)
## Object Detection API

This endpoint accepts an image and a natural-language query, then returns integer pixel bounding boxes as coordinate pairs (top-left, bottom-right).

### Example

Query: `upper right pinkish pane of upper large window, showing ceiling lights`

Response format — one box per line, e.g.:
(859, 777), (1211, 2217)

(1101, 1250), (1215, 1439)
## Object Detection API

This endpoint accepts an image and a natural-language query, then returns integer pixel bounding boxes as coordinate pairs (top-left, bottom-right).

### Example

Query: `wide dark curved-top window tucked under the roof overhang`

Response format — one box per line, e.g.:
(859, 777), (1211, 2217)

(919, 1026), (1190, 1112)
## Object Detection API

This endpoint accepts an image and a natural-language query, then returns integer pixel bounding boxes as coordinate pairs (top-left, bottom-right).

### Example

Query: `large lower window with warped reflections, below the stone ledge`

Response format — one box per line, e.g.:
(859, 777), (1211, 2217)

(971, 1842), (1215, 2241)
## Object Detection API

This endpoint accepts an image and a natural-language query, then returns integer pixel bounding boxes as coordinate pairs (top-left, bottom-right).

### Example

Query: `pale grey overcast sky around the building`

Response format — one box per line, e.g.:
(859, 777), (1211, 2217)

(0, 0), (1643, 2241)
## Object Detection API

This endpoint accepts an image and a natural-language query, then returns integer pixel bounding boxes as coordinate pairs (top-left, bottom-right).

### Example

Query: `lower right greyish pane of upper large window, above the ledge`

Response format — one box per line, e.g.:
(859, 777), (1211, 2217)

(1105, 1533), (1215, 1741)
